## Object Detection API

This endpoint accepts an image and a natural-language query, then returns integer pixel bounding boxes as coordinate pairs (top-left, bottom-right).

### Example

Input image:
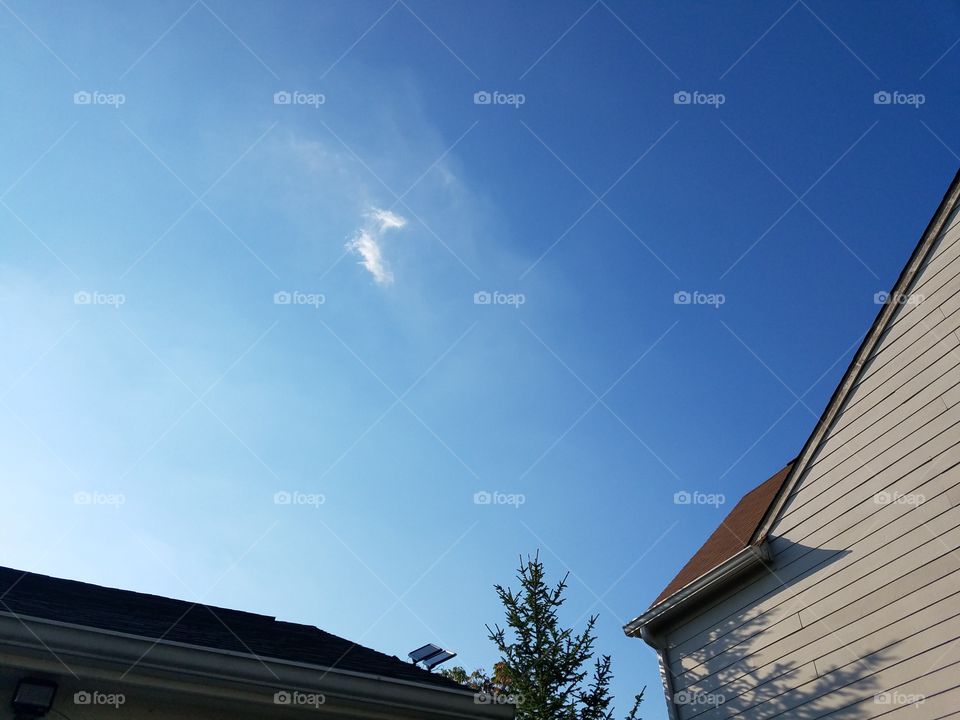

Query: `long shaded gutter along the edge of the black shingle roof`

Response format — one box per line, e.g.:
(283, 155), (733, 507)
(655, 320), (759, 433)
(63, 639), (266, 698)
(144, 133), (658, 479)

(0, 612), (514, 720)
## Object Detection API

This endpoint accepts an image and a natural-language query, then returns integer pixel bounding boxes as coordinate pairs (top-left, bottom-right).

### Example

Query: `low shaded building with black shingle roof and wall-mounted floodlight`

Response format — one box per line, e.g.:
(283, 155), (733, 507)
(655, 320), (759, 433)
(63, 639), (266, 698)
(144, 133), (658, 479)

(0, 568), (513, 720)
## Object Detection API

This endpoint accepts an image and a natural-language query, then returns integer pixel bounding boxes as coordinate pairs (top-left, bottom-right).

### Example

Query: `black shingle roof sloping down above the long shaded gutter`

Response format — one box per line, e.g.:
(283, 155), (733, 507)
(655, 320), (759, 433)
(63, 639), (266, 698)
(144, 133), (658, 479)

(0, 567), (466, 690)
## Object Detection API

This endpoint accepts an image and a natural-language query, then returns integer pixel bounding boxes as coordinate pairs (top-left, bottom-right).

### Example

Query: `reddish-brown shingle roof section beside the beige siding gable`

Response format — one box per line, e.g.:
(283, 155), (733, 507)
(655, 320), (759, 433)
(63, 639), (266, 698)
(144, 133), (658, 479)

(653, 461), (793, 605)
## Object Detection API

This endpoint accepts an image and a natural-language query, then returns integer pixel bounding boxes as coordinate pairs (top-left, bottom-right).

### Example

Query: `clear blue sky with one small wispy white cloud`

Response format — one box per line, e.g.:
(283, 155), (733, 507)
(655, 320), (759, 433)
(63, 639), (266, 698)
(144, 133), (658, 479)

(0, 0), (960, 718)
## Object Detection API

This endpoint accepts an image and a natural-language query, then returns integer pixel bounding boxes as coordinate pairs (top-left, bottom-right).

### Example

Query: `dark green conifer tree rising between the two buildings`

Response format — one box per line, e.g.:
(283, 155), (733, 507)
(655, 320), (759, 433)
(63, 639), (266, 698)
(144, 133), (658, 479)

(442, 552), (646, 720)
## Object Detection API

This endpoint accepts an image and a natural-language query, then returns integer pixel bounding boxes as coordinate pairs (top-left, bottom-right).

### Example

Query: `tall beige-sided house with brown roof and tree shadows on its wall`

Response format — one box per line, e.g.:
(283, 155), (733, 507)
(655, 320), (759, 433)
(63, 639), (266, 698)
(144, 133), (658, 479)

(624, 174), (960, 720)
